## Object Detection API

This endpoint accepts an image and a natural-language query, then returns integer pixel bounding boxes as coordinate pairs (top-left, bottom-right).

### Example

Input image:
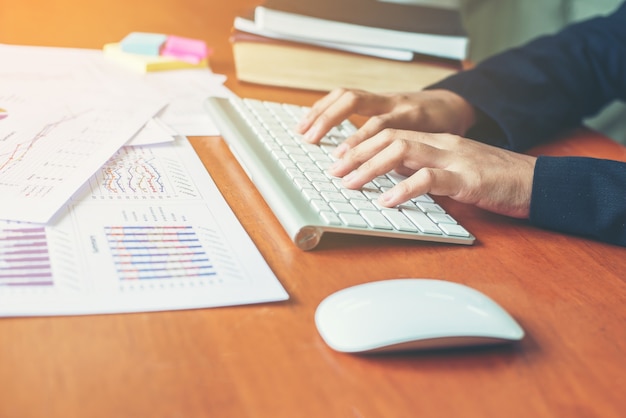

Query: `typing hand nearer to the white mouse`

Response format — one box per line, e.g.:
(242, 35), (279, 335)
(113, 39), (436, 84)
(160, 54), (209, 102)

(329, 129), (536, 218)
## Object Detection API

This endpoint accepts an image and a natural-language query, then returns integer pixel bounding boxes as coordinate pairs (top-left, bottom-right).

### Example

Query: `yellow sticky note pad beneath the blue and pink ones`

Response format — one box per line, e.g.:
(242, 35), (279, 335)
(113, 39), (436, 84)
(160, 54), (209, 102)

(103, 43), (209, 73)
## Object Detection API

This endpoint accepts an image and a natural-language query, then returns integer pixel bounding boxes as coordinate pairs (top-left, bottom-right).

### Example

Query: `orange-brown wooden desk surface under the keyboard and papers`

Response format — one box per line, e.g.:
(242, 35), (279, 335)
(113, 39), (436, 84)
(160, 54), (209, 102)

(0, 0), (626, 418)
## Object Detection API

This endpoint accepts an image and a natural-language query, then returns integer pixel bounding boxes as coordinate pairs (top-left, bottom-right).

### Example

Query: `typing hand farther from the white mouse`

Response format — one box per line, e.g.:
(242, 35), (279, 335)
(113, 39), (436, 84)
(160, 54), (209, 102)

(296, 89), (475, 152)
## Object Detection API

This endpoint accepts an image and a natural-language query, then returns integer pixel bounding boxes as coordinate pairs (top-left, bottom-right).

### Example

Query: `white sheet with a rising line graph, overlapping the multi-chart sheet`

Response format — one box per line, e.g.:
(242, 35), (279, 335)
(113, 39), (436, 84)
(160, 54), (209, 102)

(0, 100), (160, 223)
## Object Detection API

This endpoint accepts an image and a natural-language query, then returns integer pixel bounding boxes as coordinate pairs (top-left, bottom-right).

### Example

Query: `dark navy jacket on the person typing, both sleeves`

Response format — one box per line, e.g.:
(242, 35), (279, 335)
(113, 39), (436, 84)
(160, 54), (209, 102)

(429, 3), (626, 246)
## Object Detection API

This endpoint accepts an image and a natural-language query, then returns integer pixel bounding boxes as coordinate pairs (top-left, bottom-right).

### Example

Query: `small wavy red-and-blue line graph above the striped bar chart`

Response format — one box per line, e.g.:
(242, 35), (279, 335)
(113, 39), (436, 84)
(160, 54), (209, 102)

(89, 146), (198, 200)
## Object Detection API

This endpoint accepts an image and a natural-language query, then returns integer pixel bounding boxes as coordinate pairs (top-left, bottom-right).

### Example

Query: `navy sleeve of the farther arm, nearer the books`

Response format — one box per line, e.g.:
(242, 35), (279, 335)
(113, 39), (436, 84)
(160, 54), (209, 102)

(430, 6), (626, 150)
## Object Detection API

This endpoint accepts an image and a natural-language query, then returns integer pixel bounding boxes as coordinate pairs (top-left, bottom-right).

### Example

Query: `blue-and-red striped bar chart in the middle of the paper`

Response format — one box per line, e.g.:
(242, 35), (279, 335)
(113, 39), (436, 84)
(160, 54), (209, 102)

(105, 226), (217, 281)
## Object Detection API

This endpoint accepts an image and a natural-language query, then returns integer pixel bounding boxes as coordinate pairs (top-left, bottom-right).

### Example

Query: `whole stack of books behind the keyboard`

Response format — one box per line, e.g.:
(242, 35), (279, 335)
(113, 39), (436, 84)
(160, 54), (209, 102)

(230, 0), (467, 92)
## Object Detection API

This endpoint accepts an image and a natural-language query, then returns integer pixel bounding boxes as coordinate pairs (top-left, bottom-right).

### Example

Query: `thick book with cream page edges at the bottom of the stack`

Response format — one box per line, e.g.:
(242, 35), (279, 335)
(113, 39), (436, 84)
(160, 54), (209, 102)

(230, 30), (461, 93)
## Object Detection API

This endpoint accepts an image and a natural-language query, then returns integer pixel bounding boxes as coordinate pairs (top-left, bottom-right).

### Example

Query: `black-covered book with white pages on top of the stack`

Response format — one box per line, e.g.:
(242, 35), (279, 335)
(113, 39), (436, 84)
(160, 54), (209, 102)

(254, 0), (468, 60)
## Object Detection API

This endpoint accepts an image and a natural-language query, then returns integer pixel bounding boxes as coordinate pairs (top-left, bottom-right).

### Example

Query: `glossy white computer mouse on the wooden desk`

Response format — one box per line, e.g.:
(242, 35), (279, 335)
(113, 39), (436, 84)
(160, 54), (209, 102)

(315, 279), (524, 353)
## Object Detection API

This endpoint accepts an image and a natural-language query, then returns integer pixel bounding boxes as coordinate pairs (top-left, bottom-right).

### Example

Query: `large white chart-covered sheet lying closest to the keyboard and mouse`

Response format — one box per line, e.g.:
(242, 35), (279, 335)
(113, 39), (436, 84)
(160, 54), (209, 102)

(0, 138), (288, 316)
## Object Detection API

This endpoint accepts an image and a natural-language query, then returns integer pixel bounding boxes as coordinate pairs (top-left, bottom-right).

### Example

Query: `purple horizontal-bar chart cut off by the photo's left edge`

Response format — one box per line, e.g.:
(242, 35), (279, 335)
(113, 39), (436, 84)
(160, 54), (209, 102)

(0, 226), (53, 286)
